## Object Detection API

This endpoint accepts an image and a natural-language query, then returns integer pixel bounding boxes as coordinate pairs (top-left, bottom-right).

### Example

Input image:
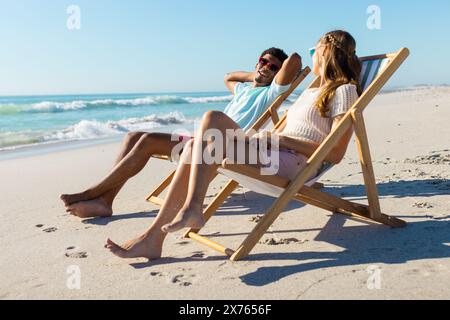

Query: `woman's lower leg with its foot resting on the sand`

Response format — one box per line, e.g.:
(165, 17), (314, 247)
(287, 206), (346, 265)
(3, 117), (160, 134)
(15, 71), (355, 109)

(105, 141), (209, 260)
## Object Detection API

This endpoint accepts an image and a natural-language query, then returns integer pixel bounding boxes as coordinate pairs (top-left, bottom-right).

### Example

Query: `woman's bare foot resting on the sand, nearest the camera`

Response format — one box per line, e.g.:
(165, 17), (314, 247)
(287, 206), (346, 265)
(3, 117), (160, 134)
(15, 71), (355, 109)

(105, 236), (162, 260)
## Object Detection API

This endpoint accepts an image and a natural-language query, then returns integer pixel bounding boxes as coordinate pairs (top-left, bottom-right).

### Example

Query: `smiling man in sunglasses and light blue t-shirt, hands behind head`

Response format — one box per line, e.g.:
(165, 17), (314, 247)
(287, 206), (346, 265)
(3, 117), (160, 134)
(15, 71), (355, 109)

(61, 48), (302, 218)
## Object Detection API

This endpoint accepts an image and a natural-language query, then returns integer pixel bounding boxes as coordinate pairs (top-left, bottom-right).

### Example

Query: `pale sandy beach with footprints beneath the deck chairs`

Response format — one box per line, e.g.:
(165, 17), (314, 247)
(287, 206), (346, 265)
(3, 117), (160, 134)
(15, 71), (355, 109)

(0, 87), (450, 300)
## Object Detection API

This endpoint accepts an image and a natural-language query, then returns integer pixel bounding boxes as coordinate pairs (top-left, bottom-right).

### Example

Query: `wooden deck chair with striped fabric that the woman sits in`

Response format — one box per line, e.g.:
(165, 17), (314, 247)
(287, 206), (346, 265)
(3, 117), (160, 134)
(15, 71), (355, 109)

(185, 48), (409, 261)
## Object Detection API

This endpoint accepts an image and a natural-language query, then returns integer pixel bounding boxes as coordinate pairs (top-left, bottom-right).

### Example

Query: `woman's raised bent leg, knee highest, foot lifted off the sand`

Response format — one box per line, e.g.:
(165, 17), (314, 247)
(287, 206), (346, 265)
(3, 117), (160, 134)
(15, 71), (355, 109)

(163, 111), (249, 232)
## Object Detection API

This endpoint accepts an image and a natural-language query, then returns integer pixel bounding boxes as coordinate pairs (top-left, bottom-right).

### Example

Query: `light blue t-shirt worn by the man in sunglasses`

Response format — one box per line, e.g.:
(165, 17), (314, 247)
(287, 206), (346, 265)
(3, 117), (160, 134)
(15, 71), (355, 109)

(224, 80), (291, 131)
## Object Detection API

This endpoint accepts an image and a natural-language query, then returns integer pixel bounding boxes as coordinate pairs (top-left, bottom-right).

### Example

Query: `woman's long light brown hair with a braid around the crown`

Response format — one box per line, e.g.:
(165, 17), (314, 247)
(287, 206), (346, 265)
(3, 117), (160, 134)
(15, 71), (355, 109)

(317, 30), (362, 118)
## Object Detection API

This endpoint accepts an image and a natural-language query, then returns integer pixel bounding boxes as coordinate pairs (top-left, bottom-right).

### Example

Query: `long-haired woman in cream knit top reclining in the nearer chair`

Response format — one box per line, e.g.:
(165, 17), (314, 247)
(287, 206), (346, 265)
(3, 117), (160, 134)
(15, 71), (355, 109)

(105, 30), (361, 260)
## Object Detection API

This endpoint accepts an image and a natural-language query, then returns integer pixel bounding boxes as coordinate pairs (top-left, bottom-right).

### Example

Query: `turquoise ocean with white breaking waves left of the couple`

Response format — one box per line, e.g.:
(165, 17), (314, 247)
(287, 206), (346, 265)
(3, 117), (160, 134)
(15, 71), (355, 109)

(0, 92), (239, 151)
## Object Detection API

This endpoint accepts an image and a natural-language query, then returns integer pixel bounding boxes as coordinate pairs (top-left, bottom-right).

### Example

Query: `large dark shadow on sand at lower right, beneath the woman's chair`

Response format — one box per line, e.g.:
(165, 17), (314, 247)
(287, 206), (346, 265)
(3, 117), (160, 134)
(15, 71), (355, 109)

(240, 215), (450, 287)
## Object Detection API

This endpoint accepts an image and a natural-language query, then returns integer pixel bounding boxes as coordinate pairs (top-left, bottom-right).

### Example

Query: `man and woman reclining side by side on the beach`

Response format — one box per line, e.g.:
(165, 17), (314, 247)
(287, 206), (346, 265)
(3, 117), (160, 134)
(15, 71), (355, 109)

(61, 31), (361, 260)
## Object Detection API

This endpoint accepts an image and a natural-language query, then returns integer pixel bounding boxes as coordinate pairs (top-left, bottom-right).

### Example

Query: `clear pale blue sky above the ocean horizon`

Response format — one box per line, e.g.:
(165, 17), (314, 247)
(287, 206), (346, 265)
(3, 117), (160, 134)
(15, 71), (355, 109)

(0, 0), (450, 95)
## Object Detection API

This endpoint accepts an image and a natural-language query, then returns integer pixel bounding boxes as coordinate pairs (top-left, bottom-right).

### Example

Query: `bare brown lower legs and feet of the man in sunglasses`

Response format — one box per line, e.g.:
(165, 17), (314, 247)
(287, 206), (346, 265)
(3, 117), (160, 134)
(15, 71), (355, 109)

(61, 133), (179, 218)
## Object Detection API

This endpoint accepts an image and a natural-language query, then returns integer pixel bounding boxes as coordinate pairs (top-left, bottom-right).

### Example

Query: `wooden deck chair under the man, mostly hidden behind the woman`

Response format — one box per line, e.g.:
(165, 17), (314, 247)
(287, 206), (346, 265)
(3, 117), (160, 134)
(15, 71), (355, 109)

(147, 67), (311, 206)
